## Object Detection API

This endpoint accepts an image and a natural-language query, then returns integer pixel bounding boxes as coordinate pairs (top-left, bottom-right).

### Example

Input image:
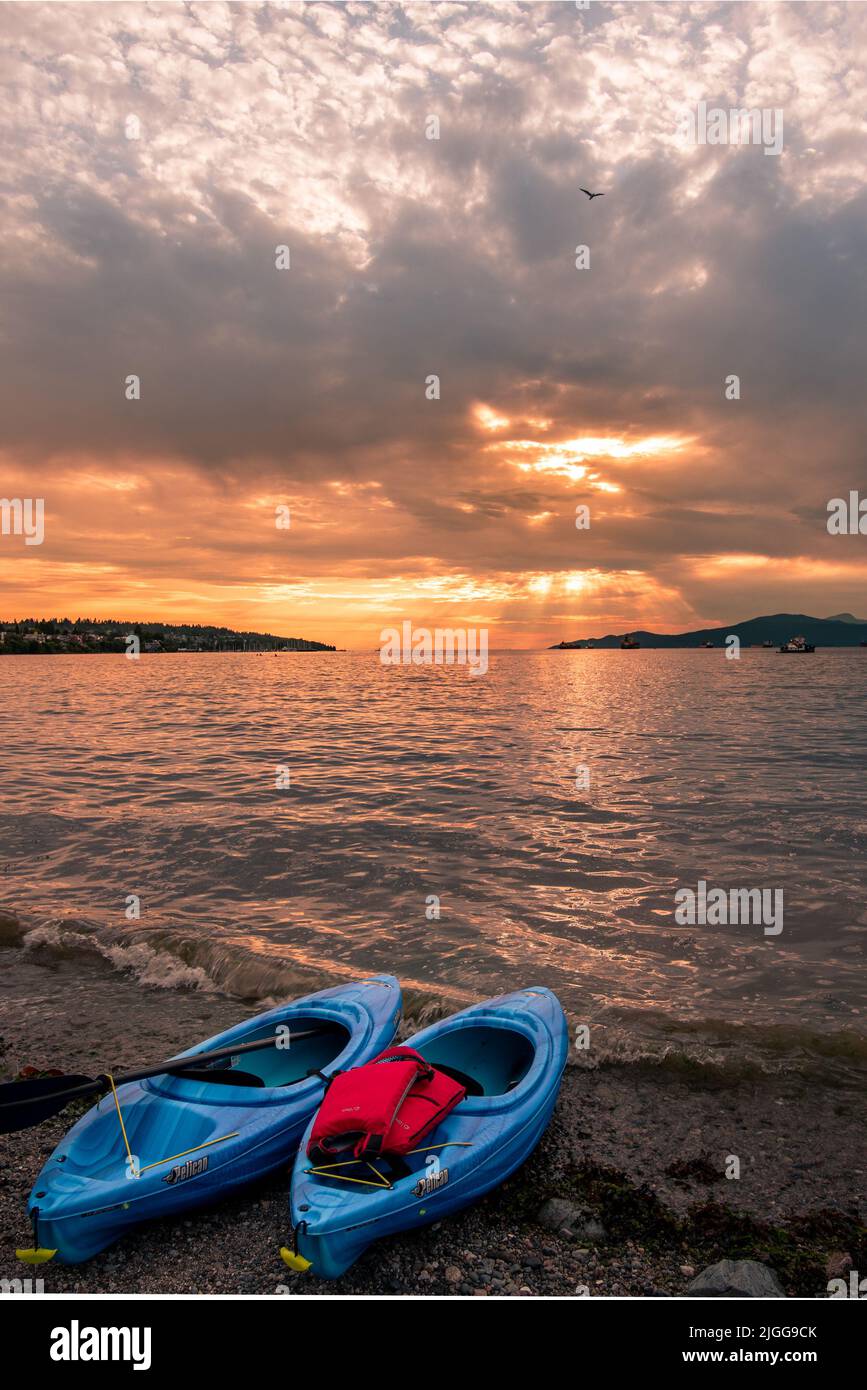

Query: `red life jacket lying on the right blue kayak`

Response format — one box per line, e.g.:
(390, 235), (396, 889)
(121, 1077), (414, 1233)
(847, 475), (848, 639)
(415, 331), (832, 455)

(307, 1047), (467, 1163)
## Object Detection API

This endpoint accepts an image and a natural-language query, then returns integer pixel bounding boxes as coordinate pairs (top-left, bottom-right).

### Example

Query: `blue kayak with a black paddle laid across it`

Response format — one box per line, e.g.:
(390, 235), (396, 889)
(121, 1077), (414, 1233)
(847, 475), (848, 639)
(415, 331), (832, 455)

(28, 974), (402, 1264)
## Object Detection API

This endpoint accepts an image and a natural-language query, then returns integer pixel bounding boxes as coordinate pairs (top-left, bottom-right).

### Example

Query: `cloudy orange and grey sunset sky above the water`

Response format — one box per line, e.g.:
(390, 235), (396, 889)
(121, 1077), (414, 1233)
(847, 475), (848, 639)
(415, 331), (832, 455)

(0, 3), (867, 648)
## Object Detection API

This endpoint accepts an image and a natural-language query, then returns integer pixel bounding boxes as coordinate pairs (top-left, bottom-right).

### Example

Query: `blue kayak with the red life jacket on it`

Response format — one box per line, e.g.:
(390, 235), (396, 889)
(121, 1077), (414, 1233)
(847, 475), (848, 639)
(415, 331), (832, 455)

(282, 987), (568, 1279)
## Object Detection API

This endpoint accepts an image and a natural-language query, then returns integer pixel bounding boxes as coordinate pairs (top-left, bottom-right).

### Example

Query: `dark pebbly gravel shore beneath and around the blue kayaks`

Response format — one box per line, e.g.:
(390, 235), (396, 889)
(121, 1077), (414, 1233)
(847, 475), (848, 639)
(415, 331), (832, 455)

(0, 951), (867, 1297)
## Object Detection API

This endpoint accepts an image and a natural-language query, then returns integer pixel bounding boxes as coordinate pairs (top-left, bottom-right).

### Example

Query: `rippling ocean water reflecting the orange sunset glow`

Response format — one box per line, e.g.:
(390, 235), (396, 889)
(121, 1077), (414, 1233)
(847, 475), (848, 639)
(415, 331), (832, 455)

(0, 649), (867, 1074)
